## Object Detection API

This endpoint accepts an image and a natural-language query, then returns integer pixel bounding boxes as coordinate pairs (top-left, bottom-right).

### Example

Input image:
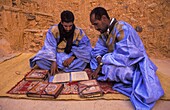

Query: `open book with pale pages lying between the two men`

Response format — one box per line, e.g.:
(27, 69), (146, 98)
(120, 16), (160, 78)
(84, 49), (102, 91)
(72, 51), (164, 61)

(49, 71), (89, 83)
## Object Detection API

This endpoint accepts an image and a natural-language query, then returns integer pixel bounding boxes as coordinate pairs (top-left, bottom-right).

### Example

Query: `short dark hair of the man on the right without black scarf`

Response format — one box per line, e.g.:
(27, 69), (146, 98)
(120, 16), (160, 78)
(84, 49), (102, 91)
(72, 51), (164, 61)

(90, 7), (110, 20)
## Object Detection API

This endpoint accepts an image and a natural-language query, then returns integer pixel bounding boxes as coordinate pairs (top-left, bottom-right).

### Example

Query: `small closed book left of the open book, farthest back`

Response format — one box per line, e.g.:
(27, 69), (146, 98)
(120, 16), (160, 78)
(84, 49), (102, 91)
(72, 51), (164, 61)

(24, 69), (48, 81)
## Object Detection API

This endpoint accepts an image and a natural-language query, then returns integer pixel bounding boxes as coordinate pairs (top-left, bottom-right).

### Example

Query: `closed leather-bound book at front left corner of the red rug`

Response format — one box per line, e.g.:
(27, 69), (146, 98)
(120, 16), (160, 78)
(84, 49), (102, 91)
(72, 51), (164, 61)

(26, 81), (64, 98)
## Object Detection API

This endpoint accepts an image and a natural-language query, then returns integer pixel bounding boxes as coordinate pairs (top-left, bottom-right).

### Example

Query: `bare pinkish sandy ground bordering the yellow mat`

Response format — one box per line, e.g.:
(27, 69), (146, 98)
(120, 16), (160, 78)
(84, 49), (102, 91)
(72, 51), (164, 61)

(0, 58), (170, 110)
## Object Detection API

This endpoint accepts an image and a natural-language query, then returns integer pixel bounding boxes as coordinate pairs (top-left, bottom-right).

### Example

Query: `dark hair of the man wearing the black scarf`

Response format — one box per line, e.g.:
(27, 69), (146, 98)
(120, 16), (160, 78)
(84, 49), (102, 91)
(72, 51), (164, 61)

(61, 10), (74, 23)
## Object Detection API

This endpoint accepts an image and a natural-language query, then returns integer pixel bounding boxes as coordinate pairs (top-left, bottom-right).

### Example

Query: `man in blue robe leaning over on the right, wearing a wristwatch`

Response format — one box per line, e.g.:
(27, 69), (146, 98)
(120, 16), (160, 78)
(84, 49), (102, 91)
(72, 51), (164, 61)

(90, 7), (164, 110)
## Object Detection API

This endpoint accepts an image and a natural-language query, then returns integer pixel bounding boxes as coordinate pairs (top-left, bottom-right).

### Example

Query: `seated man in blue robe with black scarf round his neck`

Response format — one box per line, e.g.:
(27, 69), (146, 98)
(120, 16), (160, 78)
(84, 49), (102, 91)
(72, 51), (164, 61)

(30, 11), (92, 75)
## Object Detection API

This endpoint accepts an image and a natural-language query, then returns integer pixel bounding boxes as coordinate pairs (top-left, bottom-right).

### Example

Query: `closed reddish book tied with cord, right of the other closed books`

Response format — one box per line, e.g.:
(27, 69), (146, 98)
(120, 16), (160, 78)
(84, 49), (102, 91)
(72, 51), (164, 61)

(78, 80), (103, 98)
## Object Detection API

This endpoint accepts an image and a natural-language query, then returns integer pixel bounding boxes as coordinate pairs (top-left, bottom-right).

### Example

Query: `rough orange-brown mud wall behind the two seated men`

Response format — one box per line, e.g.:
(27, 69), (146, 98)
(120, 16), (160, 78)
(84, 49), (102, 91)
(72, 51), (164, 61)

(0, 0), (170, 58)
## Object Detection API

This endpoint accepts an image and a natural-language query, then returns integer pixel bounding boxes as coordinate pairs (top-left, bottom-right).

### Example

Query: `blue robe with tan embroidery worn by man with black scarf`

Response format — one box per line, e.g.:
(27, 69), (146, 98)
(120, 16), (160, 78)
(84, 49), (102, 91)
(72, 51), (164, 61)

(30, 25), (92, 72)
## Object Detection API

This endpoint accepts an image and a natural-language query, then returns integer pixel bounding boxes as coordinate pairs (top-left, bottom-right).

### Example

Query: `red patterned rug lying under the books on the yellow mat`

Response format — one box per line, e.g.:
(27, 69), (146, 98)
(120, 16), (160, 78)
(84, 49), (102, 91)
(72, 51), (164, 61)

(7, 69), (118, 95)
